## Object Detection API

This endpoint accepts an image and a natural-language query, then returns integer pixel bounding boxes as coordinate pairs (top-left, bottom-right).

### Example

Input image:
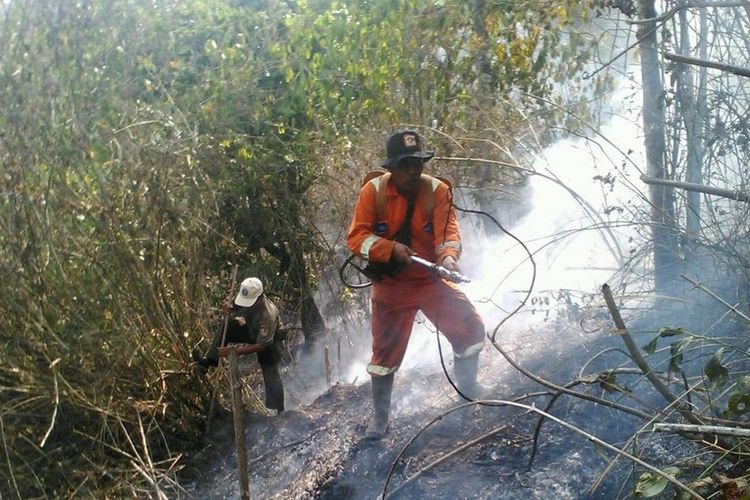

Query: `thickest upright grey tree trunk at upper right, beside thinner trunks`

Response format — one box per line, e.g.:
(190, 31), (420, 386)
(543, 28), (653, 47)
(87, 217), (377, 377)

(638, 0), (679, 290)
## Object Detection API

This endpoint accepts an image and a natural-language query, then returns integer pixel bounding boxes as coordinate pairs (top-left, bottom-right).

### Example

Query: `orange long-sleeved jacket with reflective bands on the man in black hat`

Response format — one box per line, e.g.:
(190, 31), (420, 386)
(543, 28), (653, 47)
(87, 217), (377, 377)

(347, 174), (461, 278)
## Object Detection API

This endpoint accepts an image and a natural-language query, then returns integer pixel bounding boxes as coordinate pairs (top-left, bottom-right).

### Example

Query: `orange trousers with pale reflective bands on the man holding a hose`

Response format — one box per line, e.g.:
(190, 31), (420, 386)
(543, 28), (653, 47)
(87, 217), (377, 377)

(367, 278), (484, 376)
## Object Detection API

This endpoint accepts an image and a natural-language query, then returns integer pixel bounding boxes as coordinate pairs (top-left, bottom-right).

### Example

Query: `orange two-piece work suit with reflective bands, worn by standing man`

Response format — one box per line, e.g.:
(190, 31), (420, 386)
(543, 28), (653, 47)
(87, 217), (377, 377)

(347, 175), (484, 376)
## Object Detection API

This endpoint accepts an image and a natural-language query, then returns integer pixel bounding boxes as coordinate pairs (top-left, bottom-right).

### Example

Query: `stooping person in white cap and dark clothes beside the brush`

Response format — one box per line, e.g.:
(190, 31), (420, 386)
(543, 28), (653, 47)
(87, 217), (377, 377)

(193, 278), (284, 413)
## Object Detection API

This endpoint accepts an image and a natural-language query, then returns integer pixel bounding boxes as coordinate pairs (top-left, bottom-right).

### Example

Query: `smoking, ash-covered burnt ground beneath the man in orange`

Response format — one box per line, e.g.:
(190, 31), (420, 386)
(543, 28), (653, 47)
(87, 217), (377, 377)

(179, 278), (745, 500)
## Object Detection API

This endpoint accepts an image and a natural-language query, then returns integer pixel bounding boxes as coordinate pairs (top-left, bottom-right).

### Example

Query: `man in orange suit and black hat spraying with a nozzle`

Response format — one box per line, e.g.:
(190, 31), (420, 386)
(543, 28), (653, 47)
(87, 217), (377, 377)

(347, 130), (484, 439)
